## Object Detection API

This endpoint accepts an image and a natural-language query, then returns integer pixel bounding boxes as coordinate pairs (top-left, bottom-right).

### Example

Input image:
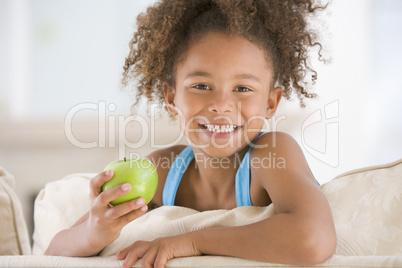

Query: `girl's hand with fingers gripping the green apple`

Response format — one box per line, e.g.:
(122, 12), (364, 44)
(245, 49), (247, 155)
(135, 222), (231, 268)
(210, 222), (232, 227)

(86, 170), (148, 250)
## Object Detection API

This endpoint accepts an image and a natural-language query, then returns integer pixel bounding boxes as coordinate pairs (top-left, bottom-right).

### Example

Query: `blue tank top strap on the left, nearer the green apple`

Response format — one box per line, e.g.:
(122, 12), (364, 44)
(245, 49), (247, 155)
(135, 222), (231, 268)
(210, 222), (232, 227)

(162, 146), (194, 206)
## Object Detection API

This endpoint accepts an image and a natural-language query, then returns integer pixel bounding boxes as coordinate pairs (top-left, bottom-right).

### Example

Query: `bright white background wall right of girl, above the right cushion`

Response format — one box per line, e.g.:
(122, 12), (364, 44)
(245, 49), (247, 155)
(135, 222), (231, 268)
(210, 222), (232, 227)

(274, 0), (402, 182)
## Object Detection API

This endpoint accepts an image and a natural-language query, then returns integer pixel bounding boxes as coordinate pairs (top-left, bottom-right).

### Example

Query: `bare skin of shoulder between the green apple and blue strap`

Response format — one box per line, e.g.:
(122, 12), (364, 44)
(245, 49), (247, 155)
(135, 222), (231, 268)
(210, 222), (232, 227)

(145, 145), (186, 209)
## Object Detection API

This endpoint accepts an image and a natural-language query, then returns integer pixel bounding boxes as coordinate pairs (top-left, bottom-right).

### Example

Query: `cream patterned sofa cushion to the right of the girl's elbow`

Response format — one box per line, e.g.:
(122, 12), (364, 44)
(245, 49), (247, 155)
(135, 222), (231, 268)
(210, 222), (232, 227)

(322, 159), (402, 256)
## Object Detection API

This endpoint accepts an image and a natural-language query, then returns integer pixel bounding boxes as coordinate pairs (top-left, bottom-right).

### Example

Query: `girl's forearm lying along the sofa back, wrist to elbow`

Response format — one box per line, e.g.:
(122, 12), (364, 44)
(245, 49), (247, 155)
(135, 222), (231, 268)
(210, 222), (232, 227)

(190, 213), (334, 265)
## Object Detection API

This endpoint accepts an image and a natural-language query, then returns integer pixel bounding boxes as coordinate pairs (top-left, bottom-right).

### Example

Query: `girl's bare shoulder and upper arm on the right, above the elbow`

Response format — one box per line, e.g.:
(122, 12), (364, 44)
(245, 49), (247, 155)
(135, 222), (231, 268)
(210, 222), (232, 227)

(250, 132), (323, 212)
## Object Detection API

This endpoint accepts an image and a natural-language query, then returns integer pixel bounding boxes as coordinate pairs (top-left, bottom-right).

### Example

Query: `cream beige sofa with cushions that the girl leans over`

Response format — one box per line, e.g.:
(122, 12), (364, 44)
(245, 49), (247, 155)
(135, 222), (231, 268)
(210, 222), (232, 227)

(0, 159), (402, 267)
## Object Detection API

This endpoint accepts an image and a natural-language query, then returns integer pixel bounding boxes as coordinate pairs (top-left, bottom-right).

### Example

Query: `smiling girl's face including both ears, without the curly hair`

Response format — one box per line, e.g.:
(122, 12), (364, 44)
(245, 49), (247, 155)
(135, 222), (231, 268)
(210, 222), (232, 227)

(164, 33), (282, 157)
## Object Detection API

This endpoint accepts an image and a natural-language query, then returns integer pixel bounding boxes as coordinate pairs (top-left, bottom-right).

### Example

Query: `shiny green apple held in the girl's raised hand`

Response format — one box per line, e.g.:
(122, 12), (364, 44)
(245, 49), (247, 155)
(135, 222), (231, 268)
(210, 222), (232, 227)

(102, 158), (158, 206)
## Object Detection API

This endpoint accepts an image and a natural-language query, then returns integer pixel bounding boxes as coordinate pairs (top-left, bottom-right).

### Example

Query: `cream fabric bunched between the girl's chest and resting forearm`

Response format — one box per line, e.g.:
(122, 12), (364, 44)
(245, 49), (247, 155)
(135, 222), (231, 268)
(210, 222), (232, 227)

(101, 205), (275, 256)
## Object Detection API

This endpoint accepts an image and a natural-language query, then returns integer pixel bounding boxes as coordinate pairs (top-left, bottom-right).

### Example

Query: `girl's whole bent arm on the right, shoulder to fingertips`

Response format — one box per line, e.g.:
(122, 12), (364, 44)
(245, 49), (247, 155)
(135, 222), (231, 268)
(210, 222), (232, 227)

(117, 133), (336, 267)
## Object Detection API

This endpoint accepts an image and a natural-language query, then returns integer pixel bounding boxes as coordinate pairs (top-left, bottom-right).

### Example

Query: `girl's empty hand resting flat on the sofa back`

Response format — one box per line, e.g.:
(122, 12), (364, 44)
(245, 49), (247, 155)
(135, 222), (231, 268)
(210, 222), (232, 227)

(116, 233), (202, 268)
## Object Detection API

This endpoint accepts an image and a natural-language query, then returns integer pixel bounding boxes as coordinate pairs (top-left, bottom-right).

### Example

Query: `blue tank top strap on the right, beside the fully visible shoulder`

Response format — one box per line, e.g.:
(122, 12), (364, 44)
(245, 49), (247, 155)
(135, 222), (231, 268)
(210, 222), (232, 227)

(236, 132), (267, 207)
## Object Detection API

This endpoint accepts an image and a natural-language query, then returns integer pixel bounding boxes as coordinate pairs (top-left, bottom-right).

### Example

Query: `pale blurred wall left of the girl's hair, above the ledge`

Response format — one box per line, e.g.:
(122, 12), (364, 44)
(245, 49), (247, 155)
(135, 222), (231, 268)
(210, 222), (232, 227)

(0, 0), (159, 120)
